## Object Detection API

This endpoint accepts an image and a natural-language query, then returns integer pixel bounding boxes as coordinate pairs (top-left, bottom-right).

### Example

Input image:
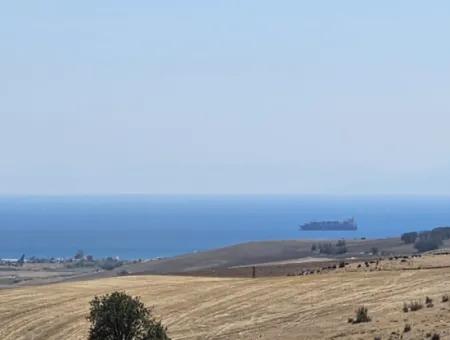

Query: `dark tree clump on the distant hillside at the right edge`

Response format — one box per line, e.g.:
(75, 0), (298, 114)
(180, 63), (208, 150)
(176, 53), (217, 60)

(401, 227), (450, 252)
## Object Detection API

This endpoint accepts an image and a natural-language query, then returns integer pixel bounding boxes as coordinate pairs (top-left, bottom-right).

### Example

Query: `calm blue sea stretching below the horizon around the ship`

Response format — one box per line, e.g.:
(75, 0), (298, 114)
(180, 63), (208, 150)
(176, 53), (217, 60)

(0, 195), (450, 259)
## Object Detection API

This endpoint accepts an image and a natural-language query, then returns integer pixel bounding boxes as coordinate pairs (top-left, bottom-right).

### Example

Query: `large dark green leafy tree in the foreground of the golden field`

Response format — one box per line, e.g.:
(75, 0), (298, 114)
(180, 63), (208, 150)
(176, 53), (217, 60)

(87, 292), (170, 340)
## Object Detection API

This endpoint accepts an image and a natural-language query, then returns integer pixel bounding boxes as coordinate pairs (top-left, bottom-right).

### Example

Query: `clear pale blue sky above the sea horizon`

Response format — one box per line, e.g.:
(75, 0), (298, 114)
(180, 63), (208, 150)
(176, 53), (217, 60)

(0, 0), (450, 194)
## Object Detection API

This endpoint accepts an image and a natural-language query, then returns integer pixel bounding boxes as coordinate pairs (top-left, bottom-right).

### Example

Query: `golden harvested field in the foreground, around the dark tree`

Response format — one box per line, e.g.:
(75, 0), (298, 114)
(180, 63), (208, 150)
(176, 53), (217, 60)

(0, 268), (450, 340)
